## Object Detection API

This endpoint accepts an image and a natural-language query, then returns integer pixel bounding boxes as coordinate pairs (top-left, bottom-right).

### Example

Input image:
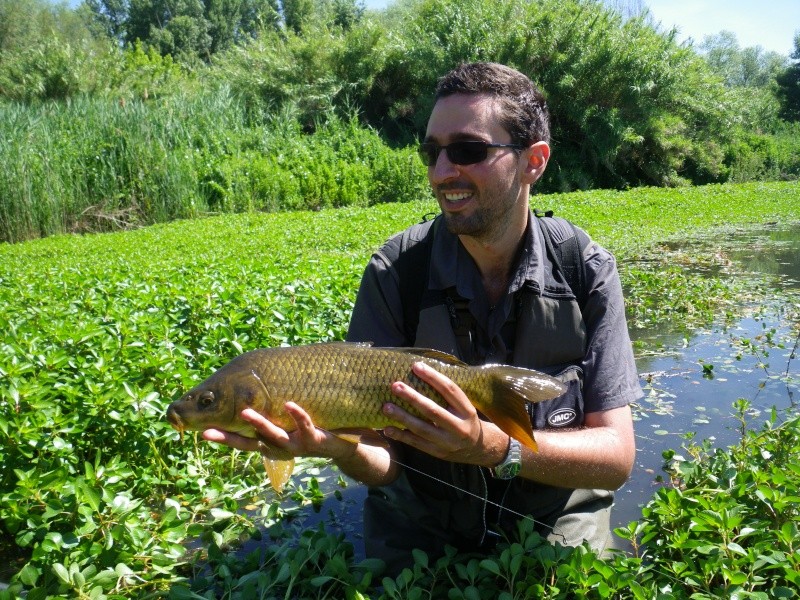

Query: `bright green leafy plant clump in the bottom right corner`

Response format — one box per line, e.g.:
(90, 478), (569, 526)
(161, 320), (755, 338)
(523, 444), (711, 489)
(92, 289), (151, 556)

(640, 400), (800, 598)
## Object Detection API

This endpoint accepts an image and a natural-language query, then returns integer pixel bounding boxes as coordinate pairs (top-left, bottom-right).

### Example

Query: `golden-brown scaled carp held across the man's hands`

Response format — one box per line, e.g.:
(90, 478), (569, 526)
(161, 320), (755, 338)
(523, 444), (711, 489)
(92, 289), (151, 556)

(166, 342), (565, 493)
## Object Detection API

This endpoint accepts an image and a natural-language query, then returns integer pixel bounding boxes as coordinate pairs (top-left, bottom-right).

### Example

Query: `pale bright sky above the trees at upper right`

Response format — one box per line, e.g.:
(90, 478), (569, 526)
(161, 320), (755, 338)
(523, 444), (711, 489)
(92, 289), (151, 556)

(365, 0), (800, 56)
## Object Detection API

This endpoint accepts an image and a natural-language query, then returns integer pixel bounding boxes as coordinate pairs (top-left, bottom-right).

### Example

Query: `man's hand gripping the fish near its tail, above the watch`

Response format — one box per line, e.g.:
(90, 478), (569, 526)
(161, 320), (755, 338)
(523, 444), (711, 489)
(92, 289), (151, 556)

(383, 362), (508, 467)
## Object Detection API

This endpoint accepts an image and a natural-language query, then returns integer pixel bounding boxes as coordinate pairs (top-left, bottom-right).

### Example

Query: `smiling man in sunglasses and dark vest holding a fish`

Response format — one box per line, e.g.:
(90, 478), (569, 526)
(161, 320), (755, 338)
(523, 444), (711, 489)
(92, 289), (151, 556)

(205, 63), (641, 574)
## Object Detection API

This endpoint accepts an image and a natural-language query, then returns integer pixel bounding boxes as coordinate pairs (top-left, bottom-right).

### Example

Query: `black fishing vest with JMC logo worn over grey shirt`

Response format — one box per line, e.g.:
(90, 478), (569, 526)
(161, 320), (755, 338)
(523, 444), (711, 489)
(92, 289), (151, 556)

(395, 216), (589, 545)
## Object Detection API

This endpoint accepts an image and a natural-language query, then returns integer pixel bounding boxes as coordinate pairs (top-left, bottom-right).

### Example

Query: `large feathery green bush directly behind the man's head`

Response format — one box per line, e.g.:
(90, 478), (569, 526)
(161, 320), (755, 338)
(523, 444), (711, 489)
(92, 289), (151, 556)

(356, 0), (732, 191)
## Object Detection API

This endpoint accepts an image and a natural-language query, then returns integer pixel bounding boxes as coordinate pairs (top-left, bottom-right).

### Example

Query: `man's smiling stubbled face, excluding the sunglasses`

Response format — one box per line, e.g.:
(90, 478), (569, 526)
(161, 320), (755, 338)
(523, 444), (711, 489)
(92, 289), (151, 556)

(425, 94), (529, 243)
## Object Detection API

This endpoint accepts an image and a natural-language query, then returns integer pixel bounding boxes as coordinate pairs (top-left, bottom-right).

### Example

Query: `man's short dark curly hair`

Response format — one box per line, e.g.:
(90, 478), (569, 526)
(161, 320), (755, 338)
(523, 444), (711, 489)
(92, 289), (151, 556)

(436, 62), (550, 146)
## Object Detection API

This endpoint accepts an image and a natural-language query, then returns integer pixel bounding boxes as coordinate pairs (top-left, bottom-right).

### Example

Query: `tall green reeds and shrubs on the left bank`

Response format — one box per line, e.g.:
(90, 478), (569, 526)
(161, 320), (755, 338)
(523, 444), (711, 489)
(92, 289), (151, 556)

(0, 86), (427, 241)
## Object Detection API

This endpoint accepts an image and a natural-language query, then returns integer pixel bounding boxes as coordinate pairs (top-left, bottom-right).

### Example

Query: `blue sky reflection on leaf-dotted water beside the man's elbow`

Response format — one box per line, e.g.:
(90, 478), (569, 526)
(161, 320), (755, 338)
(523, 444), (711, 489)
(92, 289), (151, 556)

(615, 305), (800, 524)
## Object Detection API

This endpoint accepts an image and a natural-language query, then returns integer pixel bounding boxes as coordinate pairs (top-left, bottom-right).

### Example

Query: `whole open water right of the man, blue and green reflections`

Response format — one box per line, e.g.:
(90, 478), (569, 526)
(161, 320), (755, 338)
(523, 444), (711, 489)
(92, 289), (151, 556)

(614, 224), (800, 540)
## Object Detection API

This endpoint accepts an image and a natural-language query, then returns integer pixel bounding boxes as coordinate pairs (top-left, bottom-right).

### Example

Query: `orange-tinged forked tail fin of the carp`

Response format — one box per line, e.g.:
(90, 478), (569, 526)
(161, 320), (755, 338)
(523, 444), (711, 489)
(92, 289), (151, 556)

(477, 365), (566, 452)
